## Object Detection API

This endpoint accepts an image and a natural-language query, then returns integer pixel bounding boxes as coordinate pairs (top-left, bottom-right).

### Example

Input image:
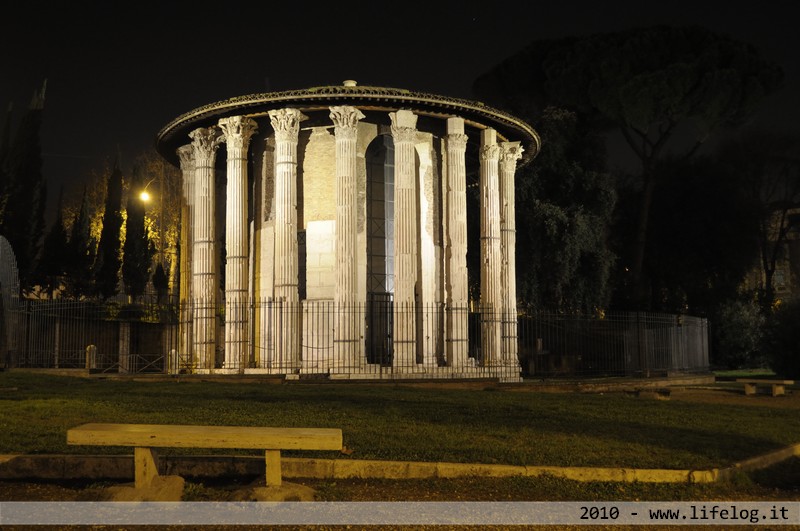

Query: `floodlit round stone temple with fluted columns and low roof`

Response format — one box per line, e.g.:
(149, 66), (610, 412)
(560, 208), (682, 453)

(158, 82), (539, 381)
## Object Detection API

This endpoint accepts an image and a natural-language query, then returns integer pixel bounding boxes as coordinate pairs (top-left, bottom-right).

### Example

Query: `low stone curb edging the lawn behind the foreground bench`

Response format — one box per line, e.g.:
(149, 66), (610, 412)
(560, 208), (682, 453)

(0, 444), (800, 483)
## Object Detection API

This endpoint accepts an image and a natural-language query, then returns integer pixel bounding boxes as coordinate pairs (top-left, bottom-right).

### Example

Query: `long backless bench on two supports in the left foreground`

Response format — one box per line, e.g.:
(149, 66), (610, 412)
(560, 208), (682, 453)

(67, 423), (342, 489)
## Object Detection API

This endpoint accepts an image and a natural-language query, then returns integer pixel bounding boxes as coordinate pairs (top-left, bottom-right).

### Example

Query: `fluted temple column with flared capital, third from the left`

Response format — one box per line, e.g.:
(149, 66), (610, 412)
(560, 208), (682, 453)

(219, 116), (257, 372)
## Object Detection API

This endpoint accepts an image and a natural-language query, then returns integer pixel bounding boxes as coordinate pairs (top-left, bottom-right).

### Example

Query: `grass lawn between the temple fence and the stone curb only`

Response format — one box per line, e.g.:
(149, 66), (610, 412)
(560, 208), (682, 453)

(0, 371), (800, 469)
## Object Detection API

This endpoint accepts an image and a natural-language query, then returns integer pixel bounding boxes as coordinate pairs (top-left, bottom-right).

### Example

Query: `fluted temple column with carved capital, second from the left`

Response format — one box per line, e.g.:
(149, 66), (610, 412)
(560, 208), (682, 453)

(189, 127), (222, 370)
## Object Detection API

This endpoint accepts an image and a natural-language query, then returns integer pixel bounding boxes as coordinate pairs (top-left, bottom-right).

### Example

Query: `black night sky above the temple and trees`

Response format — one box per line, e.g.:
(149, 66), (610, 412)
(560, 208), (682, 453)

(0, 0), (800, 214)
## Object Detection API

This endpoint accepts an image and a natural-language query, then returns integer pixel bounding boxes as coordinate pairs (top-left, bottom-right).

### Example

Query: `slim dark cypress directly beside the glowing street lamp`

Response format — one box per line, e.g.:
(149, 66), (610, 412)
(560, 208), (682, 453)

(122, 167), (155, 301)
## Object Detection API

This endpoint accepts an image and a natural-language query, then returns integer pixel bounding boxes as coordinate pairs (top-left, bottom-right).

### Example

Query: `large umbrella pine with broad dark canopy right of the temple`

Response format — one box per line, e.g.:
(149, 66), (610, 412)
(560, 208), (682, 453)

(474, 26), (783, 308)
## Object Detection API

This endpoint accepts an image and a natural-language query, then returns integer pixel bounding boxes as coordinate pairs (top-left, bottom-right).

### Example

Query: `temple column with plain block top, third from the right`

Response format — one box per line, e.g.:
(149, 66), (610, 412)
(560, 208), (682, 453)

(445, 118), (469, 367)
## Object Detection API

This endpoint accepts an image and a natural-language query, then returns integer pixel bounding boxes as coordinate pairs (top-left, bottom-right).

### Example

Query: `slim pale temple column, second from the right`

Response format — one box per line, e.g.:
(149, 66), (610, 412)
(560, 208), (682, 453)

(480, 129), (501, 366)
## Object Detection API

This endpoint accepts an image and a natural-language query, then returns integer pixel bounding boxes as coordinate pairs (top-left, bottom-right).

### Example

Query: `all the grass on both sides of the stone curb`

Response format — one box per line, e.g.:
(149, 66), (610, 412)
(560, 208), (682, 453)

(0, 371), (800, 501)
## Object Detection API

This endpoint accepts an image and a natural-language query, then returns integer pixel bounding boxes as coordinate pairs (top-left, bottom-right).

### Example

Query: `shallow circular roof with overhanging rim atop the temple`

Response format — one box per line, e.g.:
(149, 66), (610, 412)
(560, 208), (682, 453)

(156, 80), (541, 166)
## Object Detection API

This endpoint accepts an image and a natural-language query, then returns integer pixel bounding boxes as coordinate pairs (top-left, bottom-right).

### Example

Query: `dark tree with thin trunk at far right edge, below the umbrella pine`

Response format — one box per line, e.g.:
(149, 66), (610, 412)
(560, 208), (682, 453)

(719, 129), (800, 314)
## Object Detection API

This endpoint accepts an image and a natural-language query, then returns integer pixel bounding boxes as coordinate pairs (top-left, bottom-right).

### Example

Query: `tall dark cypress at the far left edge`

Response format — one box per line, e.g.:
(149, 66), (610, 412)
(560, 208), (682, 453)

(0, 84), (47, 290)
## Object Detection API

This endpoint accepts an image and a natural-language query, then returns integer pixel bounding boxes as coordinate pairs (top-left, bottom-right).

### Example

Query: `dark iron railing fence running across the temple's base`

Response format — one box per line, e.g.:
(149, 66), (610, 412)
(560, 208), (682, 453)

(6, 296), (709, 380)
